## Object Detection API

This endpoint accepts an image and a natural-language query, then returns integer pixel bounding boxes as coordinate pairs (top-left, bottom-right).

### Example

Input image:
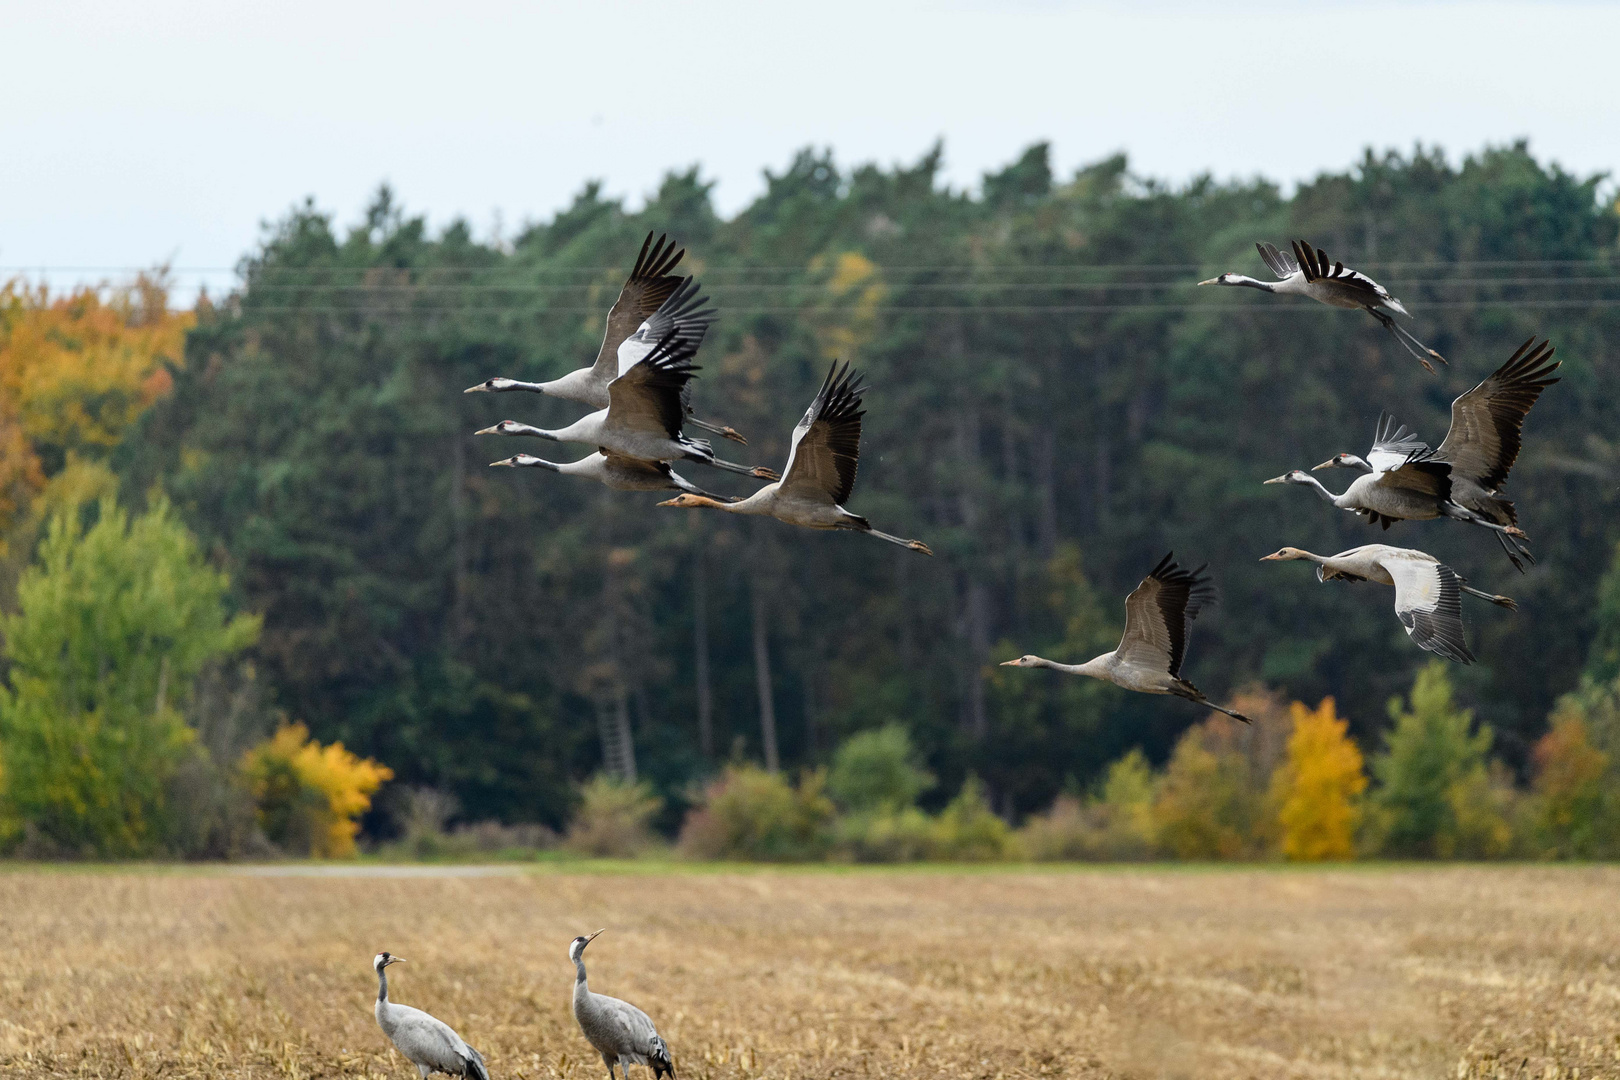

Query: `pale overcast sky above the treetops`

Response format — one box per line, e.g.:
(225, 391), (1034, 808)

(0, 0), (1620, 296)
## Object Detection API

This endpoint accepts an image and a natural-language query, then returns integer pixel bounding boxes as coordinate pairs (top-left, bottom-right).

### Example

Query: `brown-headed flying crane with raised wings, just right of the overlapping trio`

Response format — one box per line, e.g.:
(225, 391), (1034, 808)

(658, 361), (933, 555)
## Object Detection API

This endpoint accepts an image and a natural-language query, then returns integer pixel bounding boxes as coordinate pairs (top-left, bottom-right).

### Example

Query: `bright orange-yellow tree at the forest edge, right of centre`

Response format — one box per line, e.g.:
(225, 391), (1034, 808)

(1272, 698), (1367, 861)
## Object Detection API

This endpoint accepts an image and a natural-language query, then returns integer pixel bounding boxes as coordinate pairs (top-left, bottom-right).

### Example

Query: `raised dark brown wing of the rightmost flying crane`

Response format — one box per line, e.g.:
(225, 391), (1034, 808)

(1435, 338), (1562, 491)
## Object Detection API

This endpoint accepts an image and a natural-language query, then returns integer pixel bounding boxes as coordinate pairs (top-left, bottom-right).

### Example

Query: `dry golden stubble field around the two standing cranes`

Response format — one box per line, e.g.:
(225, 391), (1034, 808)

(0, 866), (1620, 1080)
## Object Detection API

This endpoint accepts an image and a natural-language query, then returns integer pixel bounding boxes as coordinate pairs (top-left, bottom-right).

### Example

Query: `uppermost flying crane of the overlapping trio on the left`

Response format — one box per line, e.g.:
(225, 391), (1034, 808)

(463, 233), (748, 444)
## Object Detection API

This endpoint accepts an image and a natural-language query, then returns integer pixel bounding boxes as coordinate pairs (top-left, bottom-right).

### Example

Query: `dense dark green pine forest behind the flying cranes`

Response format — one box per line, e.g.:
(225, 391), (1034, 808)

(107, 146), (1620, 827)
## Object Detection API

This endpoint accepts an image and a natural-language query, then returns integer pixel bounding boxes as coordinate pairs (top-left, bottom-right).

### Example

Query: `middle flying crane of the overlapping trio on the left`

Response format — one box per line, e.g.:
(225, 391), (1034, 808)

(475, 332), (776, 479)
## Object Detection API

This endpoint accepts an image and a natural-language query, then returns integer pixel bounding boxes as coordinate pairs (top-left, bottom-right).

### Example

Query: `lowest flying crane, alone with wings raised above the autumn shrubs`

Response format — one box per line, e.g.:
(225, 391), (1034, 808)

(1001, 552), (1252, 724)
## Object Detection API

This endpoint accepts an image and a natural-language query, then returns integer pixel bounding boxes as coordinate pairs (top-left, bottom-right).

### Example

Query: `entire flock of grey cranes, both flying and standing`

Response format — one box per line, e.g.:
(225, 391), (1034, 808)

(358, 235), (1558, 1080)
